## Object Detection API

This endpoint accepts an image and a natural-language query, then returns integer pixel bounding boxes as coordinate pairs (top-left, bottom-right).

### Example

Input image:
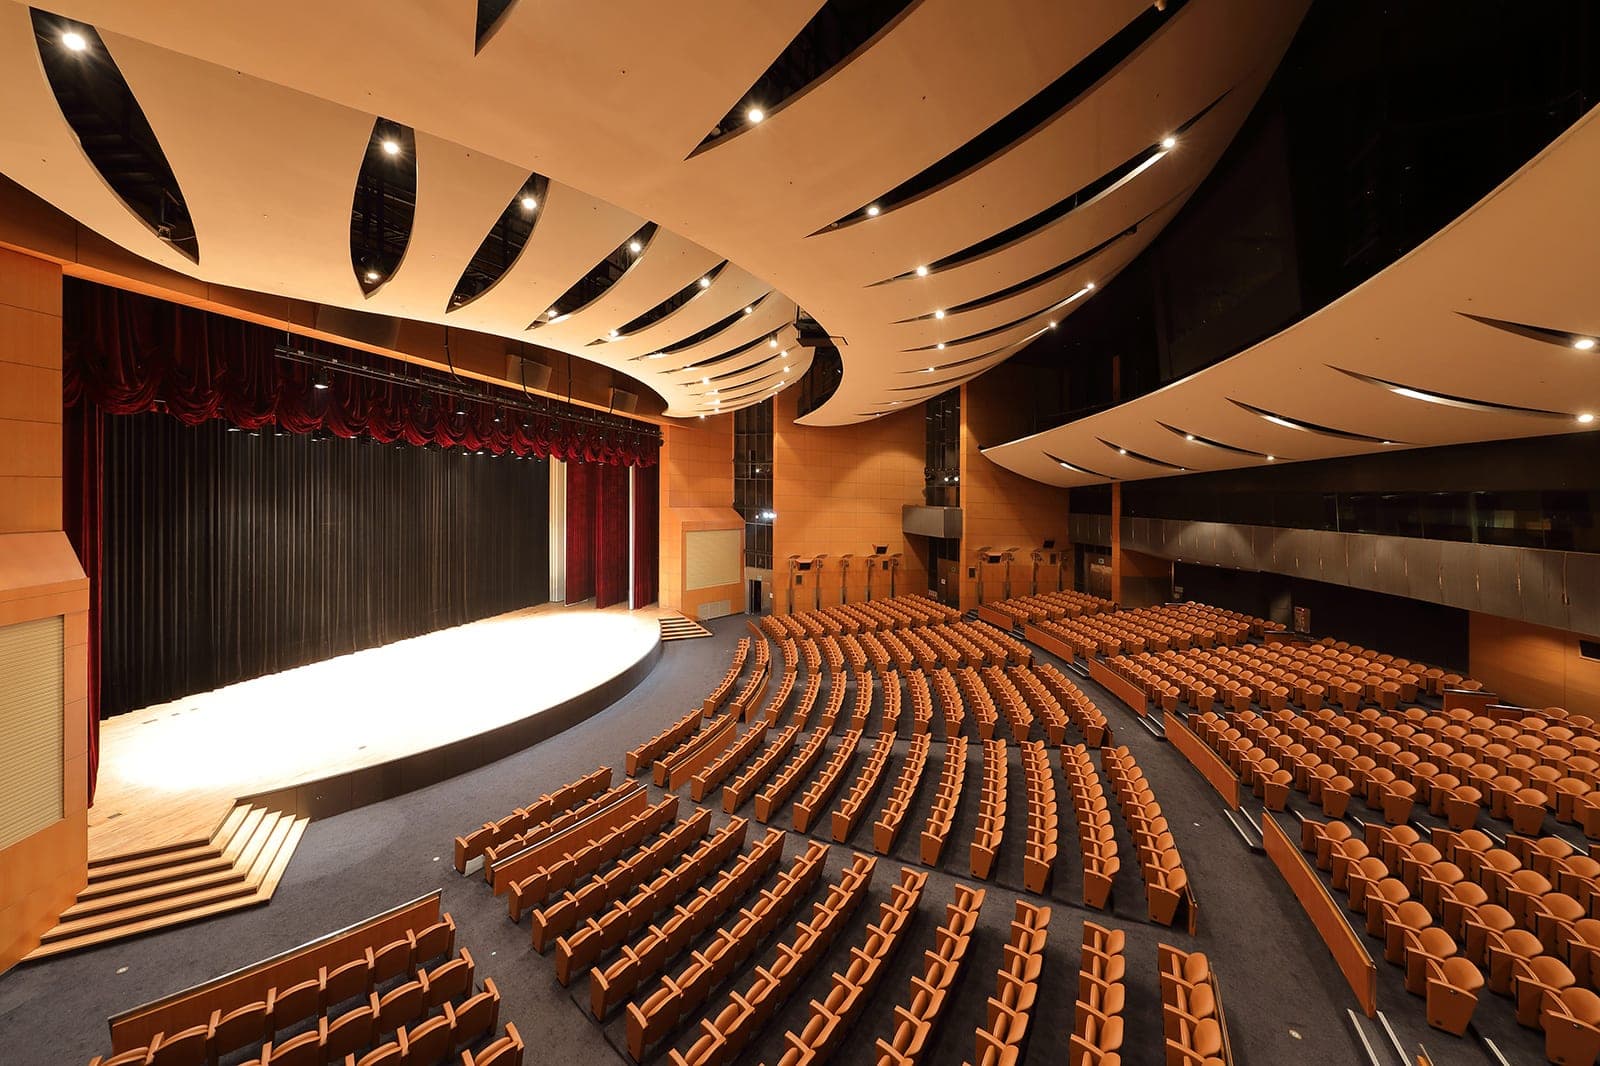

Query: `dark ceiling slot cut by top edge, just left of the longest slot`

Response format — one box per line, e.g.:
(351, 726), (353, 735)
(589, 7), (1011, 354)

(690, 0), (920, 157)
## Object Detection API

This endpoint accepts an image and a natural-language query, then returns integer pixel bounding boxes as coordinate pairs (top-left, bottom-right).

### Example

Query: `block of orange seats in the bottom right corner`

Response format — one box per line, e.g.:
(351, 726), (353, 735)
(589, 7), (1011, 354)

(1301, 820), (1600, 1064)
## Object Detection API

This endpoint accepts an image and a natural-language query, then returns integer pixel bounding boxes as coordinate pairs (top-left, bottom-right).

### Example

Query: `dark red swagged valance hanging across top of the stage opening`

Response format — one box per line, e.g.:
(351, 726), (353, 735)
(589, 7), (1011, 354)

(62, 282), (658, 466)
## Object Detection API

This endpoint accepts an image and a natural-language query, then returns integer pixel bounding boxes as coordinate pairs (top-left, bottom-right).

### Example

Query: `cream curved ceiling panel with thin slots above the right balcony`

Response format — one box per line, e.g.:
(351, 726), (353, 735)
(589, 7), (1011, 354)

(984, 101), (1600, 485)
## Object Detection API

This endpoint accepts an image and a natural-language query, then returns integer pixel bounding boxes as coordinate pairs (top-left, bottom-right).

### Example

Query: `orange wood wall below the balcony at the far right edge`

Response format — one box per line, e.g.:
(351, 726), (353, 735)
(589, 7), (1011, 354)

(1467, 613), (1600, 717)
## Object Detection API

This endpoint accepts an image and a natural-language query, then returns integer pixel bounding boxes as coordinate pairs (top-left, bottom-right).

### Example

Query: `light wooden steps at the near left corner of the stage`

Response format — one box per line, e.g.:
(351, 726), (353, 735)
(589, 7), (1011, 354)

(27, 804), (310, 960)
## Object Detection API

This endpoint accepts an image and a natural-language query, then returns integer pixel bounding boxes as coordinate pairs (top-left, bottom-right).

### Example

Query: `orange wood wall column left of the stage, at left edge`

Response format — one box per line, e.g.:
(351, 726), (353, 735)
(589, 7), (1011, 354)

(0, 248), (88, 972)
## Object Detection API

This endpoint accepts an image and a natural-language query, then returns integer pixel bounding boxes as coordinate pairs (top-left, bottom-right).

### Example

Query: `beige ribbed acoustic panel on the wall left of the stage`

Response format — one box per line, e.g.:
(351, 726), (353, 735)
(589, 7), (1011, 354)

(0, 615), (64, 850)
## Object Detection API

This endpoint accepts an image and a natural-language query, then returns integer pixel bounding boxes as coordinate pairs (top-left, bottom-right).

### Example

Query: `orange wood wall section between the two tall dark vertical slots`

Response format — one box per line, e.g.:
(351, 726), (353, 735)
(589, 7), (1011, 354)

(773, 389), (928, 613)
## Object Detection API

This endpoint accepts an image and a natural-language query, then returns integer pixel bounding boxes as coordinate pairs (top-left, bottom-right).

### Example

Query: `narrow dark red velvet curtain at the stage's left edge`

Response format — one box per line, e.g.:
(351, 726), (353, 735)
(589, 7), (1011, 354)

(61, 403), (106, 807)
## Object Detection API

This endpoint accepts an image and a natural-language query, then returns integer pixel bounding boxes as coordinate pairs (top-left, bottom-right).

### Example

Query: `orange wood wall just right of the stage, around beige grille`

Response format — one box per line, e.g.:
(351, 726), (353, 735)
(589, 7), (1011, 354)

(658, 415), (744, 618)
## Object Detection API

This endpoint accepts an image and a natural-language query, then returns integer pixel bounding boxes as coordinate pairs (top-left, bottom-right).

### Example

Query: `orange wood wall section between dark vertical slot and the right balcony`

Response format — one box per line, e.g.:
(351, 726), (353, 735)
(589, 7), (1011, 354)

(962, 386), (1072, 610)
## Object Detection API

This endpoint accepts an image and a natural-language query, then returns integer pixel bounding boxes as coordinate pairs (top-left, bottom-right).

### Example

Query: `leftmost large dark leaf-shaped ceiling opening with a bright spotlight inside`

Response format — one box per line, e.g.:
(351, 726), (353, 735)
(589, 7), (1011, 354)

(29, 8), (200, 262)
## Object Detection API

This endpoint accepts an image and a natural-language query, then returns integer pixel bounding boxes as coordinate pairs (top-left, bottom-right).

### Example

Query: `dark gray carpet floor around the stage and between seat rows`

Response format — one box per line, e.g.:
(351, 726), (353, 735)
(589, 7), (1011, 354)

(0, 618), (1542, 1066)
